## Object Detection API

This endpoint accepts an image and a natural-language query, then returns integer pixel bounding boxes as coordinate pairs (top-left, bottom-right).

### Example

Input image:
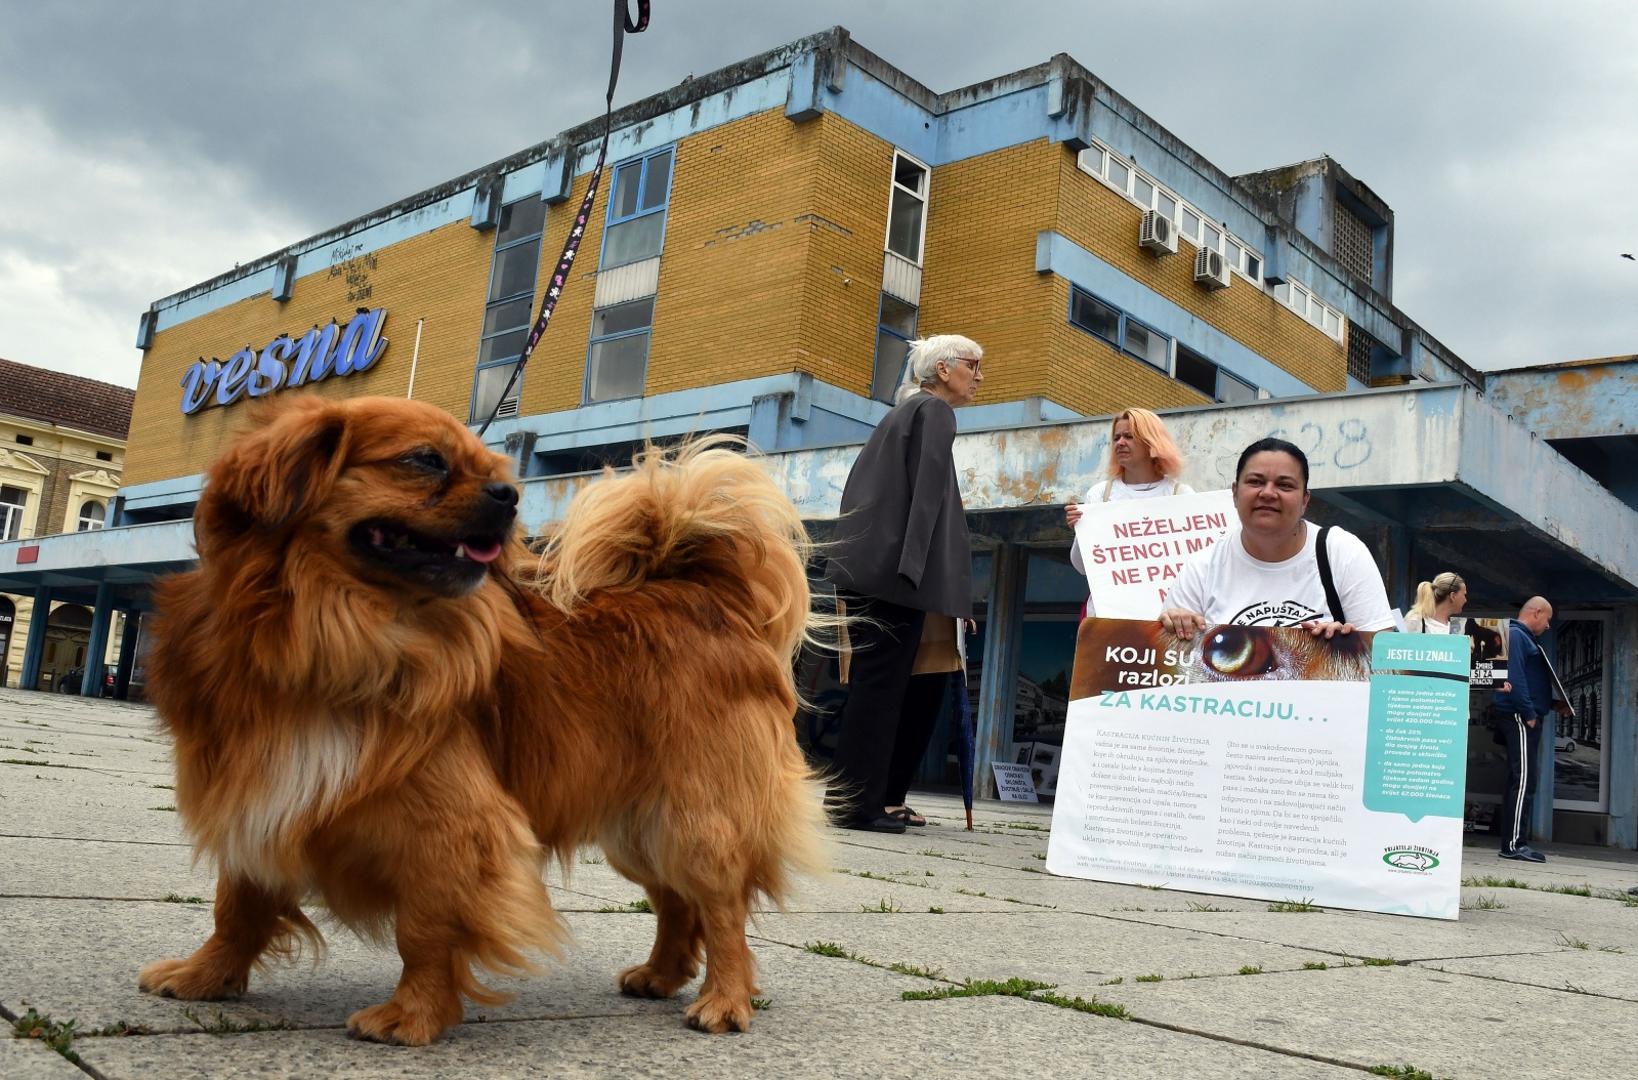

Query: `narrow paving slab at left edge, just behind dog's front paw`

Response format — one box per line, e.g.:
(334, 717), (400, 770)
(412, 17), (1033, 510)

(0, 836), (216, 900)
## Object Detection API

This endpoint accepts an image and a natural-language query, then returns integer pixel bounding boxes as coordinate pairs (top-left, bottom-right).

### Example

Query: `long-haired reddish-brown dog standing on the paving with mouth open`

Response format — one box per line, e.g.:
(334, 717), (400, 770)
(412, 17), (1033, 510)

(139, 397), (826, 1044)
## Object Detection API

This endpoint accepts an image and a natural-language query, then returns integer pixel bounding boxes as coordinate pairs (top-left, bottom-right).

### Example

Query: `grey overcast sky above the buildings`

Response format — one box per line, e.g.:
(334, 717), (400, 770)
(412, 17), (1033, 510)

(0, 0), (1638, 385)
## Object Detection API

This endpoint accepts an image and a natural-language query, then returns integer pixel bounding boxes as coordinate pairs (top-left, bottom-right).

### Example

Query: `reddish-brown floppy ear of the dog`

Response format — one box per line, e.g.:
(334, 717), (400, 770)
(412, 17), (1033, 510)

(195, 395), (349, 554)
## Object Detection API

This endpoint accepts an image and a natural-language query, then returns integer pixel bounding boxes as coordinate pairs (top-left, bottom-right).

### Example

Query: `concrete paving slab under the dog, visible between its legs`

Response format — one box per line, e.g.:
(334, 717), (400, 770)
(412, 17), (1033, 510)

(0, 900), (929, 1032)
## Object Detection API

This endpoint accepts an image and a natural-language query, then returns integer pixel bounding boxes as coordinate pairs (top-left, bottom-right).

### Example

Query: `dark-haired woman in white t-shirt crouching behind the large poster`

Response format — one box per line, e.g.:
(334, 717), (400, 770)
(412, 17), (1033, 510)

(1160, 439), (1394, 638)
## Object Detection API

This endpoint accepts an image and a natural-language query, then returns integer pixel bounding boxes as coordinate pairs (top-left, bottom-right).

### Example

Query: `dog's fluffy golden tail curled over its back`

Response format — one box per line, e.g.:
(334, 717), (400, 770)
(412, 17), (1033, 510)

(539, 434), (814, 657)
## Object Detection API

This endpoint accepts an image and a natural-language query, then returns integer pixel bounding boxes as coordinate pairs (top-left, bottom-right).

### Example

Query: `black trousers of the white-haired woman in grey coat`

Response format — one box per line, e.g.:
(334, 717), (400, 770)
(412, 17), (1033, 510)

(830, 592), (929, 818)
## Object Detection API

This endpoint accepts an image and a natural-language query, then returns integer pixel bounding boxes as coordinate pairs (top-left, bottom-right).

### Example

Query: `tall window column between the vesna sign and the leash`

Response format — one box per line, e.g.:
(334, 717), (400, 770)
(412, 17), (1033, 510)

(472, 195), (545, 423)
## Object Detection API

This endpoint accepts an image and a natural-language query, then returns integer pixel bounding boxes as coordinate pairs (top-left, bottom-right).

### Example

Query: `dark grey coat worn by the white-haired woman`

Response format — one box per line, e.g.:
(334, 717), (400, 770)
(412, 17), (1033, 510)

(826, 393), (973, 618)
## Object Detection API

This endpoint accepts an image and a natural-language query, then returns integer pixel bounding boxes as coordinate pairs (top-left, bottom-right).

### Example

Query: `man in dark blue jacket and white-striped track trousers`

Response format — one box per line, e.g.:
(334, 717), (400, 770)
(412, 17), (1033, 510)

(1491, 597), (1553, 862)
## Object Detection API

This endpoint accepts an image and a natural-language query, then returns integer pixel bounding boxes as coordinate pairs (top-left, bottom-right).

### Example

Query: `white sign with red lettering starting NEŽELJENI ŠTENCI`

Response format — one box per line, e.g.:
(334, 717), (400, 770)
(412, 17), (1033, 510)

(1075, 488), (1235, 619)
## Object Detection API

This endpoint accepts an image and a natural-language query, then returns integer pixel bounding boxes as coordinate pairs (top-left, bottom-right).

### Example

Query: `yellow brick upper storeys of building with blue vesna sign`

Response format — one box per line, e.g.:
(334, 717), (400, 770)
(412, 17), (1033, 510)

(121, 29), (1421, 501)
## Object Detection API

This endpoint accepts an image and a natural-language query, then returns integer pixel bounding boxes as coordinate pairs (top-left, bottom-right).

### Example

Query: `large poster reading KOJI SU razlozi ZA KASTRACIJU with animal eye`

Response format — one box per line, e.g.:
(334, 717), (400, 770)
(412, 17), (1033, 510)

(1047, 618), (1469, 919)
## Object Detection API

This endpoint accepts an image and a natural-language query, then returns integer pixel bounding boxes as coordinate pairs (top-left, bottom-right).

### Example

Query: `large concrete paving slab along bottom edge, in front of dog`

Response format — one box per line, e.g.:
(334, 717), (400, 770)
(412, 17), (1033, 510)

(70, 998), (1360, 1080)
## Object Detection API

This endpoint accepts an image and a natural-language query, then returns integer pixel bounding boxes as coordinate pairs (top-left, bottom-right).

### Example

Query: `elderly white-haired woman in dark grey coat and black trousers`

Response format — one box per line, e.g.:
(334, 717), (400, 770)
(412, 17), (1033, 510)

(826, 334), (984, 833)
